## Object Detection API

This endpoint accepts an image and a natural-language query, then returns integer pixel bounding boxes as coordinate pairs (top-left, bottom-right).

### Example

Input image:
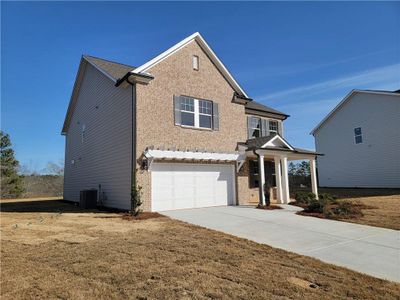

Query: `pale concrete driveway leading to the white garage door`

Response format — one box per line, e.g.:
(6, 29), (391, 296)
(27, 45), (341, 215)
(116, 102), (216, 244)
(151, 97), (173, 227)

(162, 205), (400, 282)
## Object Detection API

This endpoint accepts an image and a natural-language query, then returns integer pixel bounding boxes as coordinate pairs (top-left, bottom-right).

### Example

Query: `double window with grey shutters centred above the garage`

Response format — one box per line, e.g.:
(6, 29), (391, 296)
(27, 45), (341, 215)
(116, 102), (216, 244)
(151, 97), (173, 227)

(174, 96), (219, 130)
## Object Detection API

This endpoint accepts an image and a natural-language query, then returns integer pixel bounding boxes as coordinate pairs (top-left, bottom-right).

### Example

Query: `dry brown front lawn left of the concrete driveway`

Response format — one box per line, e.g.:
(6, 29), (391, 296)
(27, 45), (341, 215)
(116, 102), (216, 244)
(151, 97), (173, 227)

(0, 200), (400, 299)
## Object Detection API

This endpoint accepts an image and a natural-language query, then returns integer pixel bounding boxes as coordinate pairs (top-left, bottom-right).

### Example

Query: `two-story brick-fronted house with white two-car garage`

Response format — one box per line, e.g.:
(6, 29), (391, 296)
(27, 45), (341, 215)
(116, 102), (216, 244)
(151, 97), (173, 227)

(62, 33), (316, 211)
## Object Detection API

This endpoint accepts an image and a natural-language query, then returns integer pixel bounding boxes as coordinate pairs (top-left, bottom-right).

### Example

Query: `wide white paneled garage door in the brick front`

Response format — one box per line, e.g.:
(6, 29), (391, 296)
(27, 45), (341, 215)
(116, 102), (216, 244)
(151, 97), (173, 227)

(151, 163), (235, 211)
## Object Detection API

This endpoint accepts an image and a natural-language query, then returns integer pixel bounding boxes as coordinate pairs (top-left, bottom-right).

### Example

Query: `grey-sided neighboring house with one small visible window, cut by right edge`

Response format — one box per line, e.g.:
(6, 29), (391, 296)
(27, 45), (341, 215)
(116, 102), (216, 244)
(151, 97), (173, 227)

(311, 90), (400, 188)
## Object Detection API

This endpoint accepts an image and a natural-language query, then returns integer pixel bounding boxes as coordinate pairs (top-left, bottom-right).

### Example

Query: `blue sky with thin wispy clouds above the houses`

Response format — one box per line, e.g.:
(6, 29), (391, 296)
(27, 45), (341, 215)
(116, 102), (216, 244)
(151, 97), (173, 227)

(1, 2), (400, 171)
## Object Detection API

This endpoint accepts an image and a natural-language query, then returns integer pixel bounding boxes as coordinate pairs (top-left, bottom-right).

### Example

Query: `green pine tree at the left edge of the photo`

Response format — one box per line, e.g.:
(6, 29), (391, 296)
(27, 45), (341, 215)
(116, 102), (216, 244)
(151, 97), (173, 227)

(0, 130), (24, 198)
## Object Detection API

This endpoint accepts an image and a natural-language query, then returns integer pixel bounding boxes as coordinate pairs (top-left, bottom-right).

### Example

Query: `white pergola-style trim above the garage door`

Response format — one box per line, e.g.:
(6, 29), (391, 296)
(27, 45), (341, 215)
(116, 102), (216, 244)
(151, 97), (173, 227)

(144, 149), (239, 161)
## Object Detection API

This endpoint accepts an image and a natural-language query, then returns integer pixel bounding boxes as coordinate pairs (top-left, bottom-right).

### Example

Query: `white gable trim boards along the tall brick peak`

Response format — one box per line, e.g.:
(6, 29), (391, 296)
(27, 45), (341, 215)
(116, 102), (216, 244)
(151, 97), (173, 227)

(131, 32), (248, 98)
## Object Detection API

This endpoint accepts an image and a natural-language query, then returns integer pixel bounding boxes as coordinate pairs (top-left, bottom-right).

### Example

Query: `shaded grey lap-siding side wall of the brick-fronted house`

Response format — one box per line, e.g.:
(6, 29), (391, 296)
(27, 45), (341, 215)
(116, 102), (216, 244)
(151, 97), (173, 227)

(64, 64), (132, 209)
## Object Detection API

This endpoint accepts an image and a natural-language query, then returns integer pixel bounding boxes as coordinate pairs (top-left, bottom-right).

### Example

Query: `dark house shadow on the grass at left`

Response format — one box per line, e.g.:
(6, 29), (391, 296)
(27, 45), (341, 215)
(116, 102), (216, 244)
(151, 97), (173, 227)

(0, 199), (120, 213)
